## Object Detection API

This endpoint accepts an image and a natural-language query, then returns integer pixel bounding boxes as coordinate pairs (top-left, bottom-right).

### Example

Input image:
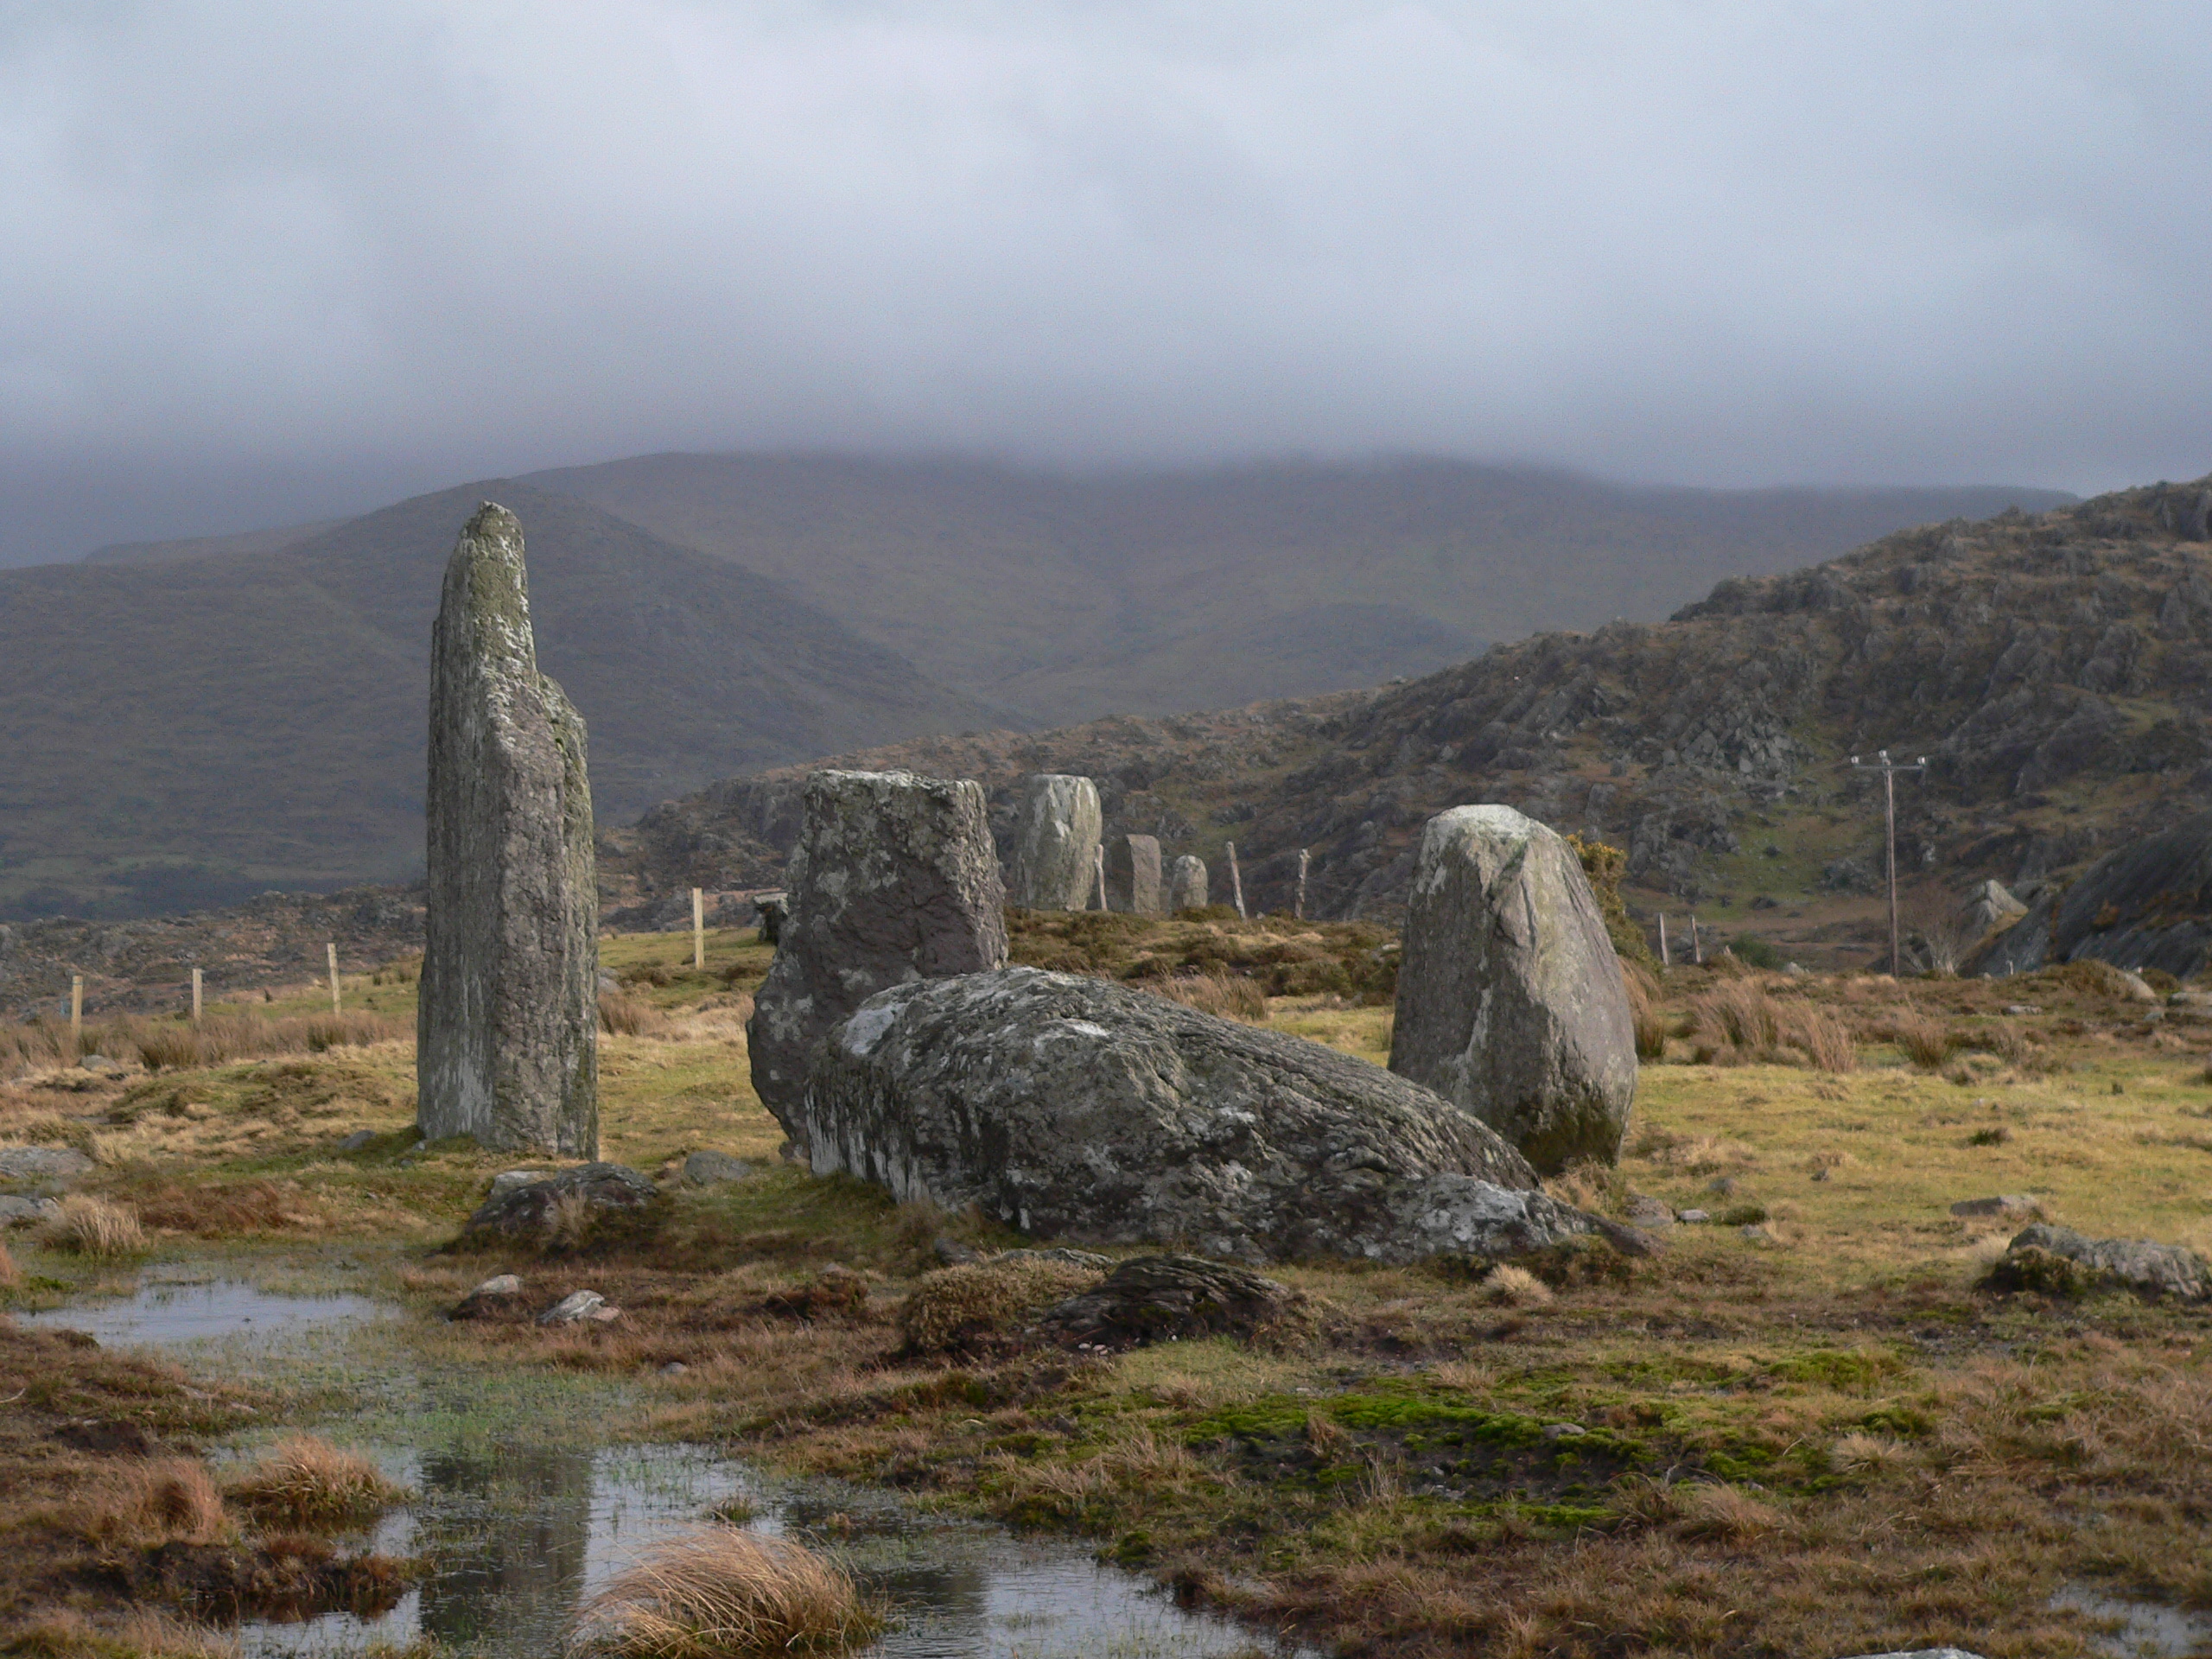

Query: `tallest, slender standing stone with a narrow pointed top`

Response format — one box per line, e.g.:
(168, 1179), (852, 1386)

(416, 502), (600, 1159)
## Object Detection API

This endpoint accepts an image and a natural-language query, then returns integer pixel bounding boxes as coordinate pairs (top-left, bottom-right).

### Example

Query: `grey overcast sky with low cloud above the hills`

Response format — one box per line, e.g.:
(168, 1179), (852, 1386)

(0, 0), (2212, 562)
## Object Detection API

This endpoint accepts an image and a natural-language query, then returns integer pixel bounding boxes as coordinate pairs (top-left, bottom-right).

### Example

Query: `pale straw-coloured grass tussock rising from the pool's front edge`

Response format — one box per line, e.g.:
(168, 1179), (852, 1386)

(564, 1526), (882, 1659)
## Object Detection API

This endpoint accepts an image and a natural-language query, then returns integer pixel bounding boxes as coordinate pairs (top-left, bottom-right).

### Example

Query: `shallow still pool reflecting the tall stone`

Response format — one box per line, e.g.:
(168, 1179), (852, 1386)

(38, 1283), (1299, 1659)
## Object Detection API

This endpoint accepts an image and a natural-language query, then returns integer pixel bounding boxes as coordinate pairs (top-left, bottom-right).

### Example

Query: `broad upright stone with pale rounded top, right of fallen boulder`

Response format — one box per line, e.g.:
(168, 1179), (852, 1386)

(1389, 805), (1637, 1174)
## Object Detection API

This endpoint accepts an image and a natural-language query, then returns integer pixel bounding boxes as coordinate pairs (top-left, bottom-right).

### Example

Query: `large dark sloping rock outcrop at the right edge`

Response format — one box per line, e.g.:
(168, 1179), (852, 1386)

(1967, 814), (2212, 980)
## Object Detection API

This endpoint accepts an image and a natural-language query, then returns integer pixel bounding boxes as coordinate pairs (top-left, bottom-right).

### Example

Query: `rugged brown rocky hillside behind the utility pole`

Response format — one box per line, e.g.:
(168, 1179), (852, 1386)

(604, 478), (2212, 960)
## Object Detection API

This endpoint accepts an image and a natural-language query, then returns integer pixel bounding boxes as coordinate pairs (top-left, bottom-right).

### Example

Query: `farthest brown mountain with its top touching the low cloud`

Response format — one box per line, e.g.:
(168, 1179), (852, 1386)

(529, 455), (2073, 726)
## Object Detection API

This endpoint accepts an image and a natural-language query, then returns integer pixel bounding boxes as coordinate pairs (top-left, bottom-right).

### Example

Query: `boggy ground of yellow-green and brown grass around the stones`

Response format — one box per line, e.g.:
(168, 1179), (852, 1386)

(0, 918), (2212, 1659)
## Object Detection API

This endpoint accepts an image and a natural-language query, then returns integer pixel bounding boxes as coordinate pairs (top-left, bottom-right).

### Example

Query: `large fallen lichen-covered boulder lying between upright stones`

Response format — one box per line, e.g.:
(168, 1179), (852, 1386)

(803, 969), (1599, 1261)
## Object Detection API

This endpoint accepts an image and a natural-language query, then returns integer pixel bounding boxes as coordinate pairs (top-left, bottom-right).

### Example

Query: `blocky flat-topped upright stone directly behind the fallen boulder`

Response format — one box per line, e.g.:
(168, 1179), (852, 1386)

(746, 772), (1013, 1157)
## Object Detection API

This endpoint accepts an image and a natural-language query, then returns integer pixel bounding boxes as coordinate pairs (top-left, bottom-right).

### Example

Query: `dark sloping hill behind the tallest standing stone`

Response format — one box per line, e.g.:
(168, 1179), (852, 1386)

(0, 482), (1004, 916)
